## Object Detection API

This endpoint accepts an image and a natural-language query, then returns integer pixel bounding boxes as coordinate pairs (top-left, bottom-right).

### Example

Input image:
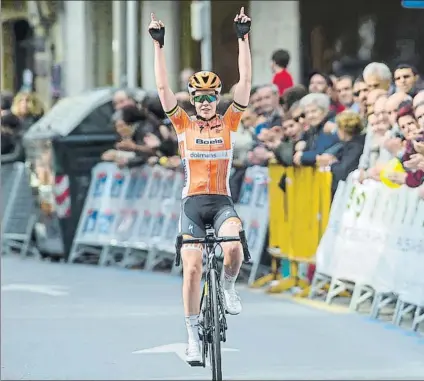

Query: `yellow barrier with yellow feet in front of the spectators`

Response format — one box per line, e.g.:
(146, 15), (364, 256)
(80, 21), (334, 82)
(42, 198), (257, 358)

(252, 164), (332, 296)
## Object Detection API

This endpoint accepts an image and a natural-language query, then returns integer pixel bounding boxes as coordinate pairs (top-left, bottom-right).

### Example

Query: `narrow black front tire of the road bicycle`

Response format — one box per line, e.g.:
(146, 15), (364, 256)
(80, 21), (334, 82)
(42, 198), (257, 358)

(208, 269), (222, 381)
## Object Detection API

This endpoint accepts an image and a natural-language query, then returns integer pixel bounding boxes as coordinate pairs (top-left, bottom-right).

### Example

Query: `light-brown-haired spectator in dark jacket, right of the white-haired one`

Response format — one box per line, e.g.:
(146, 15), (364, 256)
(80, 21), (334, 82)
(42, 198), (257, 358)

(316, 110), (365, 195)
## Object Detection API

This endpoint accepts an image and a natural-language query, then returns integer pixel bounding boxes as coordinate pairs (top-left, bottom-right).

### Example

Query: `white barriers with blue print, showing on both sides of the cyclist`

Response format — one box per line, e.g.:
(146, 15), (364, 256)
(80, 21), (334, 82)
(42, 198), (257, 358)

(69, 163), (268, 282)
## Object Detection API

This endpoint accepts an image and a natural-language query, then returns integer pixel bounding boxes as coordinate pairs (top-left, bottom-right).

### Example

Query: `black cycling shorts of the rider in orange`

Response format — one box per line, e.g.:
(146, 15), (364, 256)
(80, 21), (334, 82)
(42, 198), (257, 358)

(180, 195), (239, 238)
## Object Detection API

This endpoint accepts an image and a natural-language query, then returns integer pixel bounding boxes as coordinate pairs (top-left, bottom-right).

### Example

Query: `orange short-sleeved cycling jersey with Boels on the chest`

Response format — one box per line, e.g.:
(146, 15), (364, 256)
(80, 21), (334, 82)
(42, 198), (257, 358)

(167, 102), (245, 198)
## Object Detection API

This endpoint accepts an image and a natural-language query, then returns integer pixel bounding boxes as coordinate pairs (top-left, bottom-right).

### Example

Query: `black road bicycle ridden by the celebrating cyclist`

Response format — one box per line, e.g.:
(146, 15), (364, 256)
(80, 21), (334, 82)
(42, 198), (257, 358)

(175, 225), (250, 381)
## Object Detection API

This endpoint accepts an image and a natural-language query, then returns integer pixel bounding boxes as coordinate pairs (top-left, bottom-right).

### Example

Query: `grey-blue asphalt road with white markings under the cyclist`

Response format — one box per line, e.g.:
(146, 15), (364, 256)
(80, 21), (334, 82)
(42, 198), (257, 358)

(1, 257), (424, 380)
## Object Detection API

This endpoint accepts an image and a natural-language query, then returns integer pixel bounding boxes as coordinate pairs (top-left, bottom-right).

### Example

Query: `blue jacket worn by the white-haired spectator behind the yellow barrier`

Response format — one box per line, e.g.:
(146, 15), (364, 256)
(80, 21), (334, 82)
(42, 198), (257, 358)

(301, 119), (340, 166)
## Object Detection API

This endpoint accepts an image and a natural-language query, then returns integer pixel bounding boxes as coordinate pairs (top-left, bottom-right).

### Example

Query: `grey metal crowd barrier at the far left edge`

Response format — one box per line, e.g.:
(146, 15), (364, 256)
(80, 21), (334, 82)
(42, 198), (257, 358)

(0, 162), (38, 255)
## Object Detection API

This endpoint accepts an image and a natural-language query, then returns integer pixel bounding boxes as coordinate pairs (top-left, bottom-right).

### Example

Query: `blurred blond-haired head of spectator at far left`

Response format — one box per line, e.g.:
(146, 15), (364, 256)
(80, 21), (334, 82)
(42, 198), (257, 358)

(11, 92), (44, 133)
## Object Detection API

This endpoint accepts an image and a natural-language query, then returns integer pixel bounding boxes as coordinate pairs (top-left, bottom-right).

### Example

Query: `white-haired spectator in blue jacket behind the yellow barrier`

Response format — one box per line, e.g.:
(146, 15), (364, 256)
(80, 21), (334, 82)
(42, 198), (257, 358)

(293, 93), (339, 165)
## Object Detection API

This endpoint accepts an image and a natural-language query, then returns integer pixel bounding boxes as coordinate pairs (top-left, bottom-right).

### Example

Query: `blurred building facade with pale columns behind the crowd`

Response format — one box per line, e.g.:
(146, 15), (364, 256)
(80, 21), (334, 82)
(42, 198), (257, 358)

(1, 0), (424, 103)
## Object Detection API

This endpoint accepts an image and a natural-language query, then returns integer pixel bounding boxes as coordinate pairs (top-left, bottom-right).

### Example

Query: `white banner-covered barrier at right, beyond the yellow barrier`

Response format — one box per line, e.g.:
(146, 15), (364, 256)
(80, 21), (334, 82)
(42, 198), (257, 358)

(310, 175), (424, 330)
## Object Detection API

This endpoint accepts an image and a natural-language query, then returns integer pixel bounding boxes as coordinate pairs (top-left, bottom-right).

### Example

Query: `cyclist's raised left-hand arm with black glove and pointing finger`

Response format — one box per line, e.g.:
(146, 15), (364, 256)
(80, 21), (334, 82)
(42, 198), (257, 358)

(149, 13), (177, 112)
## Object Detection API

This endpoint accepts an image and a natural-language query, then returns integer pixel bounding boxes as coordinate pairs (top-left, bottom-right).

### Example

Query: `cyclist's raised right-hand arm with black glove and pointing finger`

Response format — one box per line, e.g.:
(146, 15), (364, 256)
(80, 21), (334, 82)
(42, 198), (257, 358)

(234, 7), (252, 106)
